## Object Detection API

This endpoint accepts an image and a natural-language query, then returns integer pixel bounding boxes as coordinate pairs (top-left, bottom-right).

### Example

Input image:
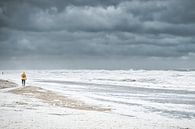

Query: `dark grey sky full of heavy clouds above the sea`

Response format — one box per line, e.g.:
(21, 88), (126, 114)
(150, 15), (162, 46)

(0, 0), (195, 69)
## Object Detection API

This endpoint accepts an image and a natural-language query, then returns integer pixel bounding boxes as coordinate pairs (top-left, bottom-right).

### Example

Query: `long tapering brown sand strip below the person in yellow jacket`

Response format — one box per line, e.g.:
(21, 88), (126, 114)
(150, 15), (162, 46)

(9, 86), (111, 111)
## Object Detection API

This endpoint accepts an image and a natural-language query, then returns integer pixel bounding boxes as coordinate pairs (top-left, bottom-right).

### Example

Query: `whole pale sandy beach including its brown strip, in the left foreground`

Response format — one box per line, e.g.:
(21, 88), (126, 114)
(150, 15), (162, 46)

(0, 80), (134, 129)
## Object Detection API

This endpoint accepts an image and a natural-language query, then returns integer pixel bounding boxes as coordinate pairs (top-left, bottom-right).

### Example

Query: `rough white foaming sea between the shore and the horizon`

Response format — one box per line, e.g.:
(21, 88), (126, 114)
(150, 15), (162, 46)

(1, 70), (195, 128)
